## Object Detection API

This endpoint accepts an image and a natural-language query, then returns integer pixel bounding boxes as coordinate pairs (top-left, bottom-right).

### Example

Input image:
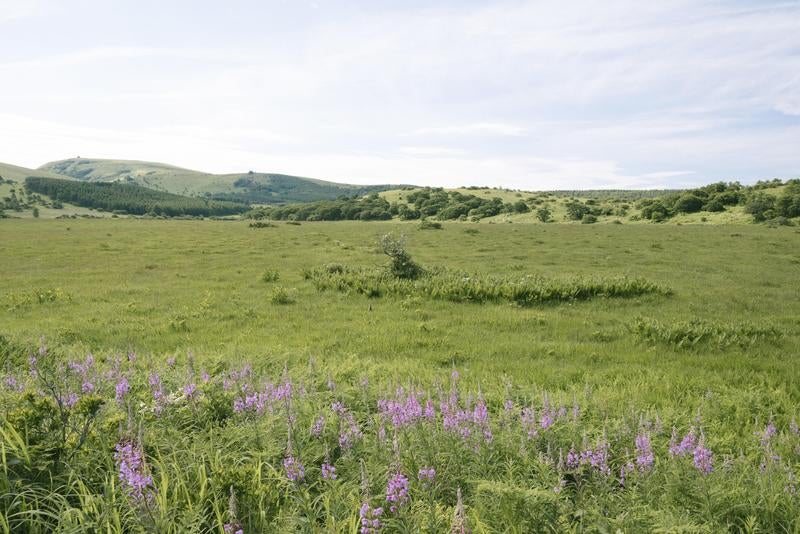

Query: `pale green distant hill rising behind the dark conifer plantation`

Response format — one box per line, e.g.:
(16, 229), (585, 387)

(40, 158), (406, 204)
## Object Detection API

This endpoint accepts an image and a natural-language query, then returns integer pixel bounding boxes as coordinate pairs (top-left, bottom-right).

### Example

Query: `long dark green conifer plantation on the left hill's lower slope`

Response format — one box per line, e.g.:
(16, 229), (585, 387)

(25, 176), (249, 217)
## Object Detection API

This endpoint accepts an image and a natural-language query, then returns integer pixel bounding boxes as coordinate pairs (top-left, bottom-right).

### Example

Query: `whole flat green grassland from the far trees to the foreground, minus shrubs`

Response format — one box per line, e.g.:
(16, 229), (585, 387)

(0, 219), (800, 532)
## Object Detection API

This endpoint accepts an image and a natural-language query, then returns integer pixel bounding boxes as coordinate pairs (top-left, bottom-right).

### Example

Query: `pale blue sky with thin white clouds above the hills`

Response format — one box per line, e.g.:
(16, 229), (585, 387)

(0, 0), (800, 190)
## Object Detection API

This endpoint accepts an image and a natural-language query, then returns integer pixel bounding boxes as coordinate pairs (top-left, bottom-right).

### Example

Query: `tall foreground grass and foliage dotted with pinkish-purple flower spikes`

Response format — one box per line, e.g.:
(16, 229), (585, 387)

(0, 351), (800, 533)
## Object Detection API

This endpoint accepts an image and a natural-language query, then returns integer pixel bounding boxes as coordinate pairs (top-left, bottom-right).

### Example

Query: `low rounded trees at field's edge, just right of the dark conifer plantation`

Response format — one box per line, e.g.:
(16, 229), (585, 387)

(248, 193), (397, 221)
